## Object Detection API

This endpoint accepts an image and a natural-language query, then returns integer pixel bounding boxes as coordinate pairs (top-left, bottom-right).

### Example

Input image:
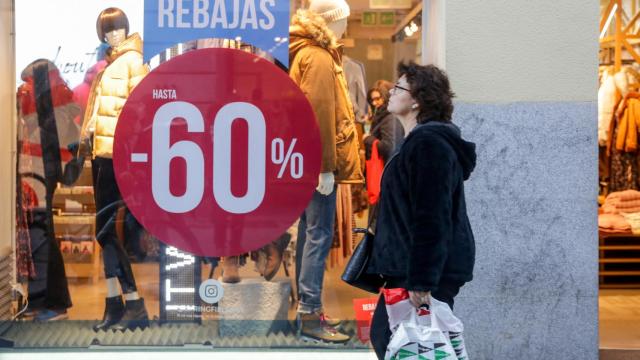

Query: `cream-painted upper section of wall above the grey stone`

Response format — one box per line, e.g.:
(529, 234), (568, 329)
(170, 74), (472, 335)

(446, 0), (599, 102)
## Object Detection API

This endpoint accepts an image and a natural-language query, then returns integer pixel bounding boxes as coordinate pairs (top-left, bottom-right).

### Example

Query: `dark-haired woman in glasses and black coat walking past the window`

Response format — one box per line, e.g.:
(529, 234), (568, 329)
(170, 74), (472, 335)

(366, 63), (476, 359)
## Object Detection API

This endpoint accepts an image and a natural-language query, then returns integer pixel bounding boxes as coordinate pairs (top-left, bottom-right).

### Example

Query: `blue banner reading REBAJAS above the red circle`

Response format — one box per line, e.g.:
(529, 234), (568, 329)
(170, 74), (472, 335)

(144, 0), (290, 67)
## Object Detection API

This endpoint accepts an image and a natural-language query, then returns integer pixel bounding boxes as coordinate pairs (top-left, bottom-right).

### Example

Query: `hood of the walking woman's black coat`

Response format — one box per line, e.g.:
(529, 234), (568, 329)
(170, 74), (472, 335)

(405, 121), (477, 180)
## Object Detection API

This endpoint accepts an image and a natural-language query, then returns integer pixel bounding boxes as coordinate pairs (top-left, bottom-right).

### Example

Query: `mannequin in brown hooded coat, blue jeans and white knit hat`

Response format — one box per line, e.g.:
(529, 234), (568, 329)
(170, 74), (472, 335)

(289, 0), (363, 343)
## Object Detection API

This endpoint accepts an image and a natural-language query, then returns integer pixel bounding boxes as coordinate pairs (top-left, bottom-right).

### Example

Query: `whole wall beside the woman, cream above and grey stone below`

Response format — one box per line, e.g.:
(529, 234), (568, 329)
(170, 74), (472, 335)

(445, 0), (599, 360)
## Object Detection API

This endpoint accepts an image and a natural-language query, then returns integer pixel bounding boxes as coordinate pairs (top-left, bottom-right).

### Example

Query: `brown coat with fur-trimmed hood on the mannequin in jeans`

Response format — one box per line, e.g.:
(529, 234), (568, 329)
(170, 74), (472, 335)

(289, 10), (364, 184)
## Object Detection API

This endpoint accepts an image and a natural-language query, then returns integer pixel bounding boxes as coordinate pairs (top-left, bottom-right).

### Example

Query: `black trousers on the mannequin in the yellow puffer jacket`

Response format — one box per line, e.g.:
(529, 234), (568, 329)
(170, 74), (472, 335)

(92, 157), (137, 294)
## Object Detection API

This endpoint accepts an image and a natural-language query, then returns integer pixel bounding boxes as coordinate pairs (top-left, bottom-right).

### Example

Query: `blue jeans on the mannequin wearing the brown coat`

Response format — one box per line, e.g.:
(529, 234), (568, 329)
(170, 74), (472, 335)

(296, 186), (336, 313)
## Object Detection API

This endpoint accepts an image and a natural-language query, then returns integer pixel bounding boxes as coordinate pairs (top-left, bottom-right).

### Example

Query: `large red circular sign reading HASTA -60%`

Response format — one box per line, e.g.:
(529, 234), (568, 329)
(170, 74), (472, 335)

(113, 49), (321, 256)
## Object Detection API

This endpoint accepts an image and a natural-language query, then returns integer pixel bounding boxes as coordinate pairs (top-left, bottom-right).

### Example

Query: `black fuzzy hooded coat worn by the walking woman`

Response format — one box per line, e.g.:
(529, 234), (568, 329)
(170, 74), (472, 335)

(367, 121), (476, 291)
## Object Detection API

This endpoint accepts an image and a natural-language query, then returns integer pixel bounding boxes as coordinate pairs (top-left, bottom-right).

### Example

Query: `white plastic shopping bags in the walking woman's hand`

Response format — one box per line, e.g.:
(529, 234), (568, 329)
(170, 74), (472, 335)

(383, 289), (469, 360)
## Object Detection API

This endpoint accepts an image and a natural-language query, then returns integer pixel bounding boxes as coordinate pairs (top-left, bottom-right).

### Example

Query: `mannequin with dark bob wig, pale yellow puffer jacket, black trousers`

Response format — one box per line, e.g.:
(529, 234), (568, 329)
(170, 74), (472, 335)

(79, 8), (149, 331)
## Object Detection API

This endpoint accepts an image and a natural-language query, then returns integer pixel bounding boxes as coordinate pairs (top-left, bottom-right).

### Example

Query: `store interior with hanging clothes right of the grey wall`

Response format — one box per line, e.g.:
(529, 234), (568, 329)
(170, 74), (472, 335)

(598, 0), (640, 349)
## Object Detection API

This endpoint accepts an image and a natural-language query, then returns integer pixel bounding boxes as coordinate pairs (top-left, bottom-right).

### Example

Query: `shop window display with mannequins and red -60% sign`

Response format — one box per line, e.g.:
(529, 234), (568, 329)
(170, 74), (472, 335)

(0, 0), (430, 349)
